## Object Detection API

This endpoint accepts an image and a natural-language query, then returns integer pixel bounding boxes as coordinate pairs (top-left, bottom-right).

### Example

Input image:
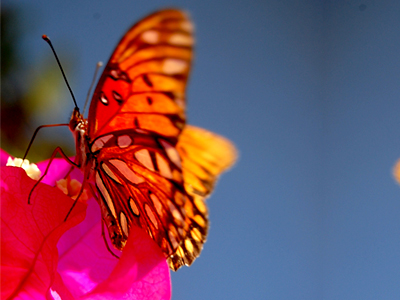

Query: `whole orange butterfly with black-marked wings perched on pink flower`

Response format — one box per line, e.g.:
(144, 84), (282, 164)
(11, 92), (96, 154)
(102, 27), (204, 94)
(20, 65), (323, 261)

(69, 9), (236, 271)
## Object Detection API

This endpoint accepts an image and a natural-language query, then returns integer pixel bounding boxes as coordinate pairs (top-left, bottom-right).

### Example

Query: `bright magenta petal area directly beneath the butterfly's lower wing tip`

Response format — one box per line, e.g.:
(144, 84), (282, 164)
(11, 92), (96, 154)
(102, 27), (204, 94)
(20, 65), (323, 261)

(58, 199), (171, 299)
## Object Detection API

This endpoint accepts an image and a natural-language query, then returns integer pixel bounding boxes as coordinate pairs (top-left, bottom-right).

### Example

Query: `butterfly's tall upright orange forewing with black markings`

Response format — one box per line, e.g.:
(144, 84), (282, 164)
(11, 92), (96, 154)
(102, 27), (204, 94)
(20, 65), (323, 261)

(88, 10), (194, 141)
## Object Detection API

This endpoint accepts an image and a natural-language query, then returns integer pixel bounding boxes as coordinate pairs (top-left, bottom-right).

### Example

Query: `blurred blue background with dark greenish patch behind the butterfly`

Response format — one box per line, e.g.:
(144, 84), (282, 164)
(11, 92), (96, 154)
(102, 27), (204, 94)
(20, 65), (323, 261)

(1, 0), (400, 300)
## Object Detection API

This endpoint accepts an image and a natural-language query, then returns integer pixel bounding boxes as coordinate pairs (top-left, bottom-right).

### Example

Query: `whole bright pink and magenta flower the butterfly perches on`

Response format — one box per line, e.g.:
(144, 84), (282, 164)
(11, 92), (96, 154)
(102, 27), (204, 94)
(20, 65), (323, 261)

(0, 150), (171, 300)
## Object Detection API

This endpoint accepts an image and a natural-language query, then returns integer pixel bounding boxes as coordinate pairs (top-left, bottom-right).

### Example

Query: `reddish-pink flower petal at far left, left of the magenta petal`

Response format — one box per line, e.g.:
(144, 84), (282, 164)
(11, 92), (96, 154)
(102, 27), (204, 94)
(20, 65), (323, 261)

(1, 167), (86, 299)
